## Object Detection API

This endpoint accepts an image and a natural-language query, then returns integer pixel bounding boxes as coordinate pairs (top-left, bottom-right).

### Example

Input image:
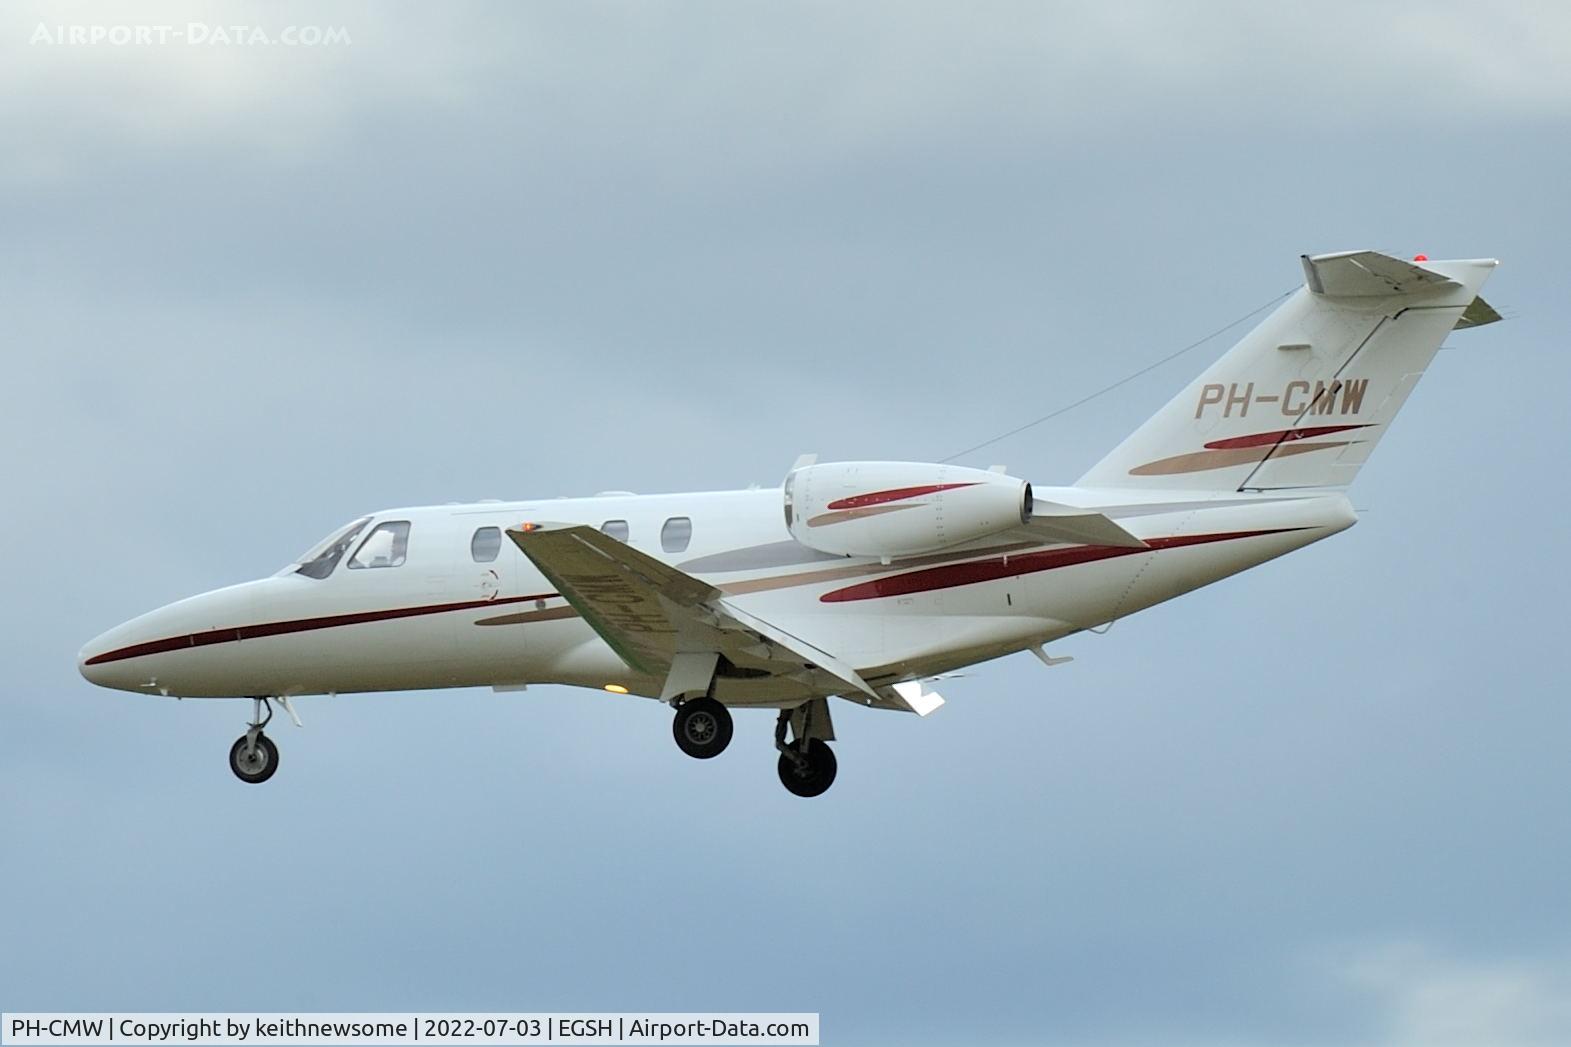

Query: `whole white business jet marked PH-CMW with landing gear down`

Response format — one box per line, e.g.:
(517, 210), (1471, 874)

(80, 252), (1500, 795)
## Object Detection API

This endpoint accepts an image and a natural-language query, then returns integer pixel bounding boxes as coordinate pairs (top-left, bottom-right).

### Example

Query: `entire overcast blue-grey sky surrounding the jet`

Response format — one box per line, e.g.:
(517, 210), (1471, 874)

(0, 2), (1571, 1047)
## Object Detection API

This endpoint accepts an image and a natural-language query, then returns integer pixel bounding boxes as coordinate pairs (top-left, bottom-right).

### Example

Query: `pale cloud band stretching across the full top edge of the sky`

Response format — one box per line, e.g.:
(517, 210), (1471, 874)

(0, 0), (1571, 175)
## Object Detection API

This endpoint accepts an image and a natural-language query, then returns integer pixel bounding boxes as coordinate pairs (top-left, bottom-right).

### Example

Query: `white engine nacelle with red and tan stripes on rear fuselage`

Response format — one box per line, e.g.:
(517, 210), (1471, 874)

(786, 462), (1031, 558)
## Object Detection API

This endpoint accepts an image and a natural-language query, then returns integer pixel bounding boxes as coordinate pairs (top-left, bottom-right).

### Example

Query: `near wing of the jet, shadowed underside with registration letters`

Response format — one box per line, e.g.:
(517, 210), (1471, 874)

(507, 524), (917, 711)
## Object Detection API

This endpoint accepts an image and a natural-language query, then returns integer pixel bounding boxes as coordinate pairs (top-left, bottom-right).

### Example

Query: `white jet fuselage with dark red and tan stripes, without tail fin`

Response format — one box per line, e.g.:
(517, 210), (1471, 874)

(80, 487), (1356, 707)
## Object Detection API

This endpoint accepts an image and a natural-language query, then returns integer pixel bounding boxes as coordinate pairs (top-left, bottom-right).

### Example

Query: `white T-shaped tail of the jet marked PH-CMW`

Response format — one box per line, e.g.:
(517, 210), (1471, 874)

(1078, 252), (1500, 490)
